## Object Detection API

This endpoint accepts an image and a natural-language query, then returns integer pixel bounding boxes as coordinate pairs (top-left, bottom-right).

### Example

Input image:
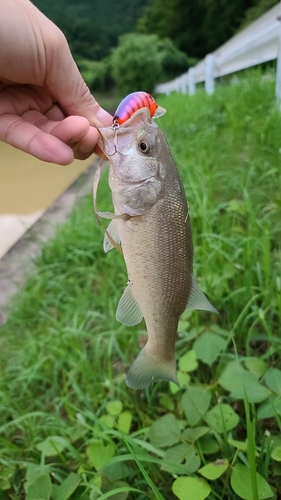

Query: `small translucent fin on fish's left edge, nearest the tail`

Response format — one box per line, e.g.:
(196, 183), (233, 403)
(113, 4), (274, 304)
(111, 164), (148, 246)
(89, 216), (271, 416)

(116, 283), (143, 326)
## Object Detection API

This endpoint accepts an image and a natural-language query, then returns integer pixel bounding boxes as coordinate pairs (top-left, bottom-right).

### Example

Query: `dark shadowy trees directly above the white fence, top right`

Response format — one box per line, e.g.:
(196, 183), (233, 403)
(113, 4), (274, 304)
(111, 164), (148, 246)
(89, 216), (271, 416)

(137, 0), (278, 59)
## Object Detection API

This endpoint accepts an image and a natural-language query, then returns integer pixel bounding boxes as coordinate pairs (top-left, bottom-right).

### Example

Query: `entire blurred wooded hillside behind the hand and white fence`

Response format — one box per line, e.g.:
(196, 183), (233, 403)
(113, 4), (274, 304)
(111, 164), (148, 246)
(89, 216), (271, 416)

(30, 0), (278, 96)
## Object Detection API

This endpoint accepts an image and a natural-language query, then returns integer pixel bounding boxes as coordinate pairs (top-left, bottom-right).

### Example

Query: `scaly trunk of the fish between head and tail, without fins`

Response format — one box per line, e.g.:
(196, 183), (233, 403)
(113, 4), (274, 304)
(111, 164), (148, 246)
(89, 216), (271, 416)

(118, 193), (192, 362)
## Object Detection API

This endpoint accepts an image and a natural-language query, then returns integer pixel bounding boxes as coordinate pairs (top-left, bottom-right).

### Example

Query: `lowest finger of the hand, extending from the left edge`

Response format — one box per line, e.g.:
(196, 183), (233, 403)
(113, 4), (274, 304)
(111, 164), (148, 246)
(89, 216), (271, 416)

(0, 114), (74, 165)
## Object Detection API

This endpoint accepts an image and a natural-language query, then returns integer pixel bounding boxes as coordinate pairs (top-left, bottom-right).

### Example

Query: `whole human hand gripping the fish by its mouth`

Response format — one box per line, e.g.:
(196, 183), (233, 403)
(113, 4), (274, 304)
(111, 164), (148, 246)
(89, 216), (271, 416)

(0, 0), (112, 165)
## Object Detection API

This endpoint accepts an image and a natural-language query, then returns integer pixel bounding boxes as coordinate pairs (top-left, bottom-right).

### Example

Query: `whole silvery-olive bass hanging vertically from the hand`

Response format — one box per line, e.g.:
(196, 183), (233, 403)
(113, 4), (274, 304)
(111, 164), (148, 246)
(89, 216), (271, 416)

(94, 103), (217, 389)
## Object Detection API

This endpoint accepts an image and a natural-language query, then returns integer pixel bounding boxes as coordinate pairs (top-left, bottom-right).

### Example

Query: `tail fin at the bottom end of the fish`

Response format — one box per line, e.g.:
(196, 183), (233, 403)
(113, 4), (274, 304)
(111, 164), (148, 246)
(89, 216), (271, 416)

(126, 347), (178, 389)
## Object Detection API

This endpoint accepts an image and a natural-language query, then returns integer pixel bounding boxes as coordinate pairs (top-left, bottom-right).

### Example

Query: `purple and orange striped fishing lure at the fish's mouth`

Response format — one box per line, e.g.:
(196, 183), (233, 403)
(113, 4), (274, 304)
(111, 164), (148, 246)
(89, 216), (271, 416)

(113, 91), (165, 125)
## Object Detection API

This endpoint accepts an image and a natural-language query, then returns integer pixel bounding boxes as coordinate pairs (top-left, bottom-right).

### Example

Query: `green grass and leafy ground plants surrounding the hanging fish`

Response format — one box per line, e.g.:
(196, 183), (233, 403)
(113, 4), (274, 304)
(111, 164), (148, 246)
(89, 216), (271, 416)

(0, 71), (281, 500)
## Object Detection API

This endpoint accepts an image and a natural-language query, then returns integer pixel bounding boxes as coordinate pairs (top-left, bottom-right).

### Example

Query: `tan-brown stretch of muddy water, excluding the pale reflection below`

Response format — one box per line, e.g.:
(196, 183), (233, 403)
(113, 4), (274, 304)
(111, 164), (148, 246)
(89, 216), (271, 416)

(0, 141), (94, 215)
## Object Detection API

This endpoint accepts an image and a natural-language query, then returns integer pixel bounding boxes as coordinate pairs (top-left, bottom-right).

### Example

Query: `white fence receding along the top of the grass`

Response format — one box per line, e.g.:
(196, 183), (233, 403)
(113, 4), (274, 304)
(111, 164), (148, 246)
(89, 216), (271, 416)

(155, 2), (281, 99)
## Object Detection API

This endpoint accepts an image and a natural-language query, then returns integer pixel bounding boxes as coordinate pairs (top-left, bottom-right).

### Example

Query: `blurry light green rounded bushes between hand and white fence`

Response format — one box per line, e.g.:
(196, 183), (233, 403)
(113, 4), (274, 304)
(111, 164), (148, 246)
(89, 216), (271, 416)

(77, 35), (190, 94)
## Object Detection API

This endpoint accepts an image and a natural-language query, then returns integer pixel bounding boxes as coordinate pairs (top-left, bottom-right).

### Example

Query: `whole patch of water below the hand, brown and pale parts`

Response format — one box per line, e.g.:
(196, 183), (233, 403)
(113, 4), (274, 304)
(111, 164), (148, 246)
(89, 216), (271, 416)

(0, 141), (94, 258)
